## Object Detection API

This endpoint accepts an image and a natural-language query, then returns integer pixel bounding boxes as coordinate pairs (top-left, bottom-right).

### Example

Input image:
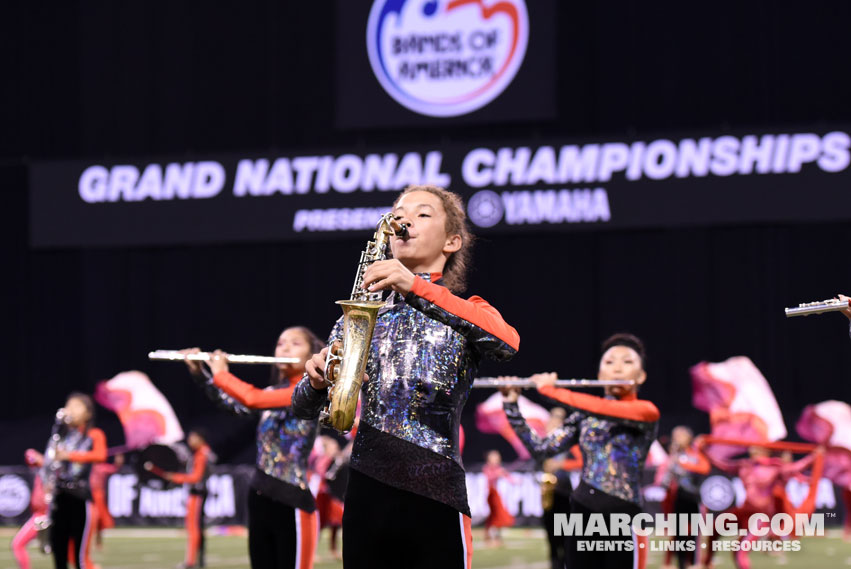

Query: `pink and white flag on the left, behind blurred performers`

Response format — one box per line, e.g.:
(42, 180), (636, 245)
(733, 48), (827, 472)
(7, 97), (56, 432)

(95, 371), (183, 449)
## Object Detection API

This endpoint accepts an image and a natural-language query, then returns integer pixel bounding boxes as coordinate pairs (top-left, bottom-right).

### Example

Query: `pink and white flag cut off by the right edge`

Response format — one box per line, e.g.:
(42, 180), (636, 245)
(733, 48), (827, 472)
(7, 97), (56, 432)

(795, 401), (851, 488)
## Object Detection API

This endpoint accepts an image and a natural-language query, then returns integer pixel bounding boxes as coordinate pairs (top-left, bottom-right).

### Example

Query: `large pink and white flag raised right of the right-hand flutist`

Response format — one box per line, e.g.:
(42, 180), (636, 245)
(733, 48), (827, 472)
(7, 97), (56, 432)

(691, 356), (787, 459)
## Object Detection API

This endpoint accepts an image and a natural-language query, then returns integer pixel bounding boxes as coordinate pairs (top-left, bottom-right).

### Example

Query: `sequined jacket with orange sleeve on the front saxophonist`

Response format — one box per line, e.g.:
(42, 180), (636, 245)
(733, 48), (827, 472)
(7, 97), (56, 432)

(293, 274), (520, 516)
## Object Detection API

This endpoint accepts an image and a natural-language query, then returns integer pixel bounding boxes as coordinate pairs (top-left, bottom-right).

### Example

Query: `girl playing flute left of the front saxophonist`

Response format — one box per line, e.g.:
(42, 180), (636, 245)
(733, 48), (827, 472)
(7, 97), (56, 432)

(186, 326), (324, 569)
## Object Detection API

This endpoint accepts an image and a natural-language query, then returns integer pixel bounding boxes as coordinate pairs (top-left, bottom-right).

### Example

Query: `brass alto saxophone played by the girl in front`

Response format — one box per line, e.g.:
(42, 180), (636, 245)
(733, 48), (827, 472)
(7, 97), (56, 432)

(321, 213), (408, 433)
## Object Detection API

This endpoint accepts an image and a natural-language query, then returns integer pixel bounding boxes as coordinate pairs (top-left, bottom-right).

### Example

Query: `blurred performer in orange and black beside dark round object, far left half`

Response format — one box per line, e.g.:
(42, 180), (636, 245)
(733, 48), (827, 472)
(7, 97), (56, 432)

(144, 429), (214, 569)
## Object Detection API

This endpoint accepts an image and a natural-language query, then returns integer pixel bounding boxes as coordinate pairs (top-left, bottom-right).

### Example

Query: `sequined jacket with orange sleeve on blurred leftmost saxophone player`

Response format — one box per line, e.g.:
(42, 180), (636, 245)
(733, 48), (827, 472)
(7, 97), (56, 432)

(48, 428), (106, 500)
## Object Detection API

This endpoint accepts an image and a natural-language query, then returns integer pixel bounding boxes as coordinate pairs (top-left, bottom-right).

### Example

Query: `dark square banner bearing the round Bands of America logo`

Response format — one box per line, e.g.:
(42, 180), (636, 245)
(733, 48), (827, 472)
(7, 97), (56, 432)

(336, 0), (556, 128)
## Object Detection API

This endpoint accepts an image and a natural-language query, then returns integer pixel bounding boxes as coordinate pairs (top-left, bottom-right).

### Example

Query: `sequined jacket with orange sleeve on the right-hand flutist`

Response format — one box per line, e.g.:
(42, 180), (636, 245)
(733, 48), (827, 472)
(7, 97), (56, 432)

(504, 386), (659, 508)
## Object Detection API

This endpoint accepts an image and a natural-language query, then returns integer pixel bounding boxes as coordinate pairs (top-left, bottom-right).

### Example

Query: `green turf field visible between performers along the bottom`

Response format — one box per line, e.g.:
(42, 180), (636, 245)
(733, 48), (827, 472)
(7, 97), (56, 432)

(0, 528), (851, 569)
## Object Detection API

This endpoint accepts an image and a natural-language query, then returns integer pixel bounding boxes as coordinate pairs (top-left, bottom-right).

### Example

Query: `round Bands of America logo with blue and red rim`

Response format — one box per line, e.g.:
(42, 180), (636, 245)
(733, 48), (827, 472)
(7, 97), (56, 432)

(366, 0), (529, 117)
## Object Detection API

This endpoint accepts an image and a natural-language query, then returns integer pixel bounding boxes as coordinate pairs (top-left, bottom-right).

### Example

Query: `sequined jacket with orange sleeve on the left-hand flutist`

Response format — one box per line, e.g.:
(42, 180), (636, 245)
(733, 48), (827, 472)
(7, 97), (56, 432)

(199, 372), (318, 512)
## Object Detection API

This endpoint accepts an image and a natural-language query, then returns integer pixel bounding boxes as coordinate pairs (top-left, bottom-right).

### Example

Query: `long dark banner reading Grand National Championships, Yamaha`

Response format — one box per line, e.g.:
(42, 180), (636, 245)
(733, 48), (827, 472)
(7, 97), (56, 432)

(30, 129), (851, 247)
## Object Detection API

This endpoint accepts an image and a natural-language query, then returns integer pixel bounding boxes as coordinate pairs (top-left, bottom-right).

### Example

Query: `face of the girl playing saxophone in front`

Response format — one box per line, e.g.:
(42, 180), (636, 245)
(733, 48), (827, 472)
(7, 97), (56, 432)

(390, 191), (461, 273)
